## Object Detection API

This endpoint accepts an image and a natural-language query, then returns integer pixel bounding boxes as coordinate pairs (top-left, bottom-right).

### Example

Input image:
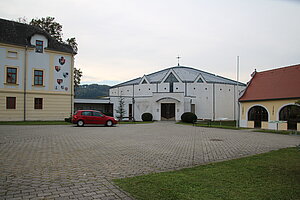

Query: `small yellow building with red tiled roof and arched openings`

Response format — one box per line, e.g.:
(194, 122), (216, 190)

(239, 65), (300, 131)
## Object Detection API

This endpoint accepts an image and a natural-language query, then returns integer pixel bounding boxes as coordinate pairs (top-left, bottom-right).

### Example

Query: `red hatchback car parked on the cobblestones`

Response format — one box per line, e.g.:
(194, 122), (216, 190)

(72, 110), (118, 126)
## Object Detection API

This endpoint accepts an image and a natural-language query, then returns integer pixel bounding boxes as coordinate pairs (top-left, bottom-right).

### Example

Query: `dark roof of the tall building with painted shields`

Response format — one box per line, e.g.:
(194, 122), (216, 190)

(0, 19), (76, 54)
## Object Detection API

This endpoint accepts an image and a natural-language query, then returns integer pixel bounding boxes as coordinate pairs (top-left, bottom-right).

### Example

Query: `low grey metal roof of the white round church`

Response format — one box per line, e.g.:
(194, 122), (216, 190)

(113, 66), (246, 87)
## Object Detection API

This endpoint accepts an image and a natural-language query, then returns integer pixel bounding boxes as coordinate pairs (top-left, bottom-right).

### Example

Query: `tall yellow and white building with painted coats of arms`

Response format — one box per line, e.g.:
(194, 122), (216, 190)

(0, 19), (75, 121)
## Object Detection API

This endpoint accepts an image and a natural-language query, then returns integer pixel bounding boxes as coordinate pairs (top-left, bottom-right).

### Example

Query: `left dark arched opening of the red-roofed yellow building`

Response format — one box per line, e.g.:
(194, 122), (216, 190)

(248, 106), (268, 128)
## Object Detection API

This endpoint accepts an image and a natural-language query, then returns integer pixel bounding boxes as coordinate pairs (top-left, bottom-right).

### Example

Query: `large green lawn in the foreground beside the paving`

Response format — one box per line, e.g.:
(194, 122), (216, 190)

(114, 147), (300, 200)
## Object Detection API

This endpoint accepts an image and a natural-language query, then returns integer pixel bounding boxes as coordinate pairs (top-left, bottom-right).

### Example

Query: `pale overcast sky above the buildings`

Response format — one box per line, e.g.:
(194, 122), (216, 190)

(0, 0), (300, 85)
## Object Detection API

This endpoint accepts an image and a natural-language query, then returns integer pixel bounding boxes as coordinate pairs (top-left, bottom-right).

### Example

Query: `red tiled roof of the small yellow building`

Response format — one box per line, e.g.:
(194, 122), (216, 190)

(239, 64), (300, 101)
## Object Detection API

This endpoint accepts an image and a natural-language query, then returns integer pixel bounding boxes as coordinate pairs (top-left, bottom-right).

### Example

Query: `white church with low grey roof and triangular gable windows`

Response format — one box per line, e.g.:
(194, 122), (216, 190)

(109, 66), (246, 121)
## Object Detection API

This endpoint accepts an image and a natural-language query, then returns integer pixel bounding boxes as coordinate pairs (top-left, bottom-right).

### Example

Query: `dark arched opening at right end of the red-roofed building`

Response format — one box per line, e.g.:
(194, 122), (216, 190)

(279, 105), (300, 130)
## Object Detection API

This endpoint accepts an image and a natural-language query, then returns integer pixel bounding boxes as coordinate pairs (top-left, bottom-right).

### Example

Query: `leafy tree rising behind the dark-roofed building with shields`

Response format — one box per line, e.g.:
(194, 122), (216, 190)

(24, 16), (82, 88)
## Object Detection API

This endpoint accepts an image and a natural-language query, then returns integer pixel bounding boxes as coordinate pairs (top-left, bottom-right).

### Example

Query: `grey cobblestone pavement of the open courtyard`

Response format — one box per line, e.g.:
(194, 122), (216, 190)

(0, 122), (300, 199)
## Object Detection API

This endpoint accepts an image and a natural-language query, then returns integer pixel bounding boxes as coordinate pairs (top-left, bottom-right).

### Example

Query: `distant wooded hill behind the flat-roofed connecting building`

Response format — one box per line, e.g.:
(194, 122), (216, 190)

(75, 84), (110, 99)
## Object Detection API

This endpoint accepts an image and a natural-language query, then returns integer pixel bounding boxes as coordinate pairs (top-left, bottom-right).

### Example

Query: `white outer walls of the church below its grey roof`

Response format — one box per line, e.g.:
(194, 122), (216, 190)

(109, 82), (244, 120)
